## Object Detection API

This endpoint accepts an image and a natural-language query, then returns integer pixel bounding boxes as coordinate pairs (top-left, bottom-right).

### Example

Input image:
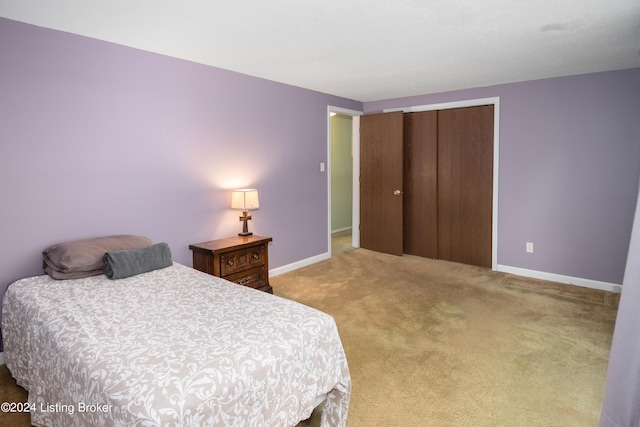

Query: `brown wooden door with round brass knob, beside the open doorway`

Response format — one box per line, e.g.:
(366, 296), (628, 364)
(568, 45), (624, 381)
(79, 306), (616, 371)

(360, 112), (403, 255)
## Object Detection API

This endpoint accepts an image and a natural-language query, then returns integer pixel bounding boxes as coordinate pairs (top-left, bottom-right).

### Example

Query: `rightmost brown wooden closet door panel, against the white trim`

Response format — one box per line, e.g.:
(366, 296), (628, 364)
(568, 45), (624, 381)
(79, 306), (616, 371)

(438, 105), (493, 268)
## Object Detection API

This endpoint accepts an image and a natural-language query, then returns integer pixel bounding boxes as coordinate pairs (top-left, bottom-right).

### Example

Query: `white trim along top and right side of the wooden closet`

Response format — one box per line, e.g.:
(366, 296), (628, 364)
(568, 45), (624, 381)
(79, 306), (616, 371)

(383, 96), (500, 270)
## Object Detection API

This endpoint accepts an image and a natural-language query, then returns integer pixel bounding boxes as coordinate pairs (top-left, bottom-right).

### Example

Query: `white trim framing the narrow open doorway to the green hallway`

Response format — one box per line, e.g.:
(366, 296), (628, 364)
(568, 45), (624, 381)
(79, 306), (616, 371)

(326, 105), (364, 257)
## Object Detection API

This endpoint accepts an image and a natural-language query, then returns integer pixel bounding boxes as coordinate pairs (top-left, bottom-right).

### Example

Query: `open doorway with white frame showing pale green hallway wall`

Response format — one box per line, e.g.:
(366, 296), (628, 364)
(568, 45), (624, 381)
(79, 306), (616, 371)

(328, 106), (362, 256)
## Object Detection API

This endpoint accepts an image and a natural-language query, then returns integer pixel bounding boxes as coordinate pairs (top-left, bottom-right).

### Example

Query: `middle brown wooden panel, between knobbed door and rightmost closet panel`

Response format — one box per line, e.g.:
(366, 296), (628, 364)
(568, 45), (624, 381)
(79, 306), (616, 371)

(403, 111), (438, 258)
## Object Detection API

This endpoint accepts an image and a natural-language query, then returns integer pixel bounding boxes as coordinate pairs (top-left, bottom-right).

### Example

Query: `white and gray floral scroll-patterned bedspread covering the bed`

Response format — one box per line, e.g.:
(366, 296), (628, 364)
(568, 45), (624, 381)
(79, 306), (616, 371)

(2, 263), (351, 427)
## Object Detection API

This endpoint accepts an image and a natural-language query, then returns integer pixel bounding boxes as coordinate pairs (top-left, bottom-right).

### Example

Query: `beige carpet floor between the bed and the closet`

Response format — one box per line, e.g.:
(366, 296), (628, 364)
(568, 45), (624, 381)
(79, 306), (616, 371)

(270, 249), (618, 427)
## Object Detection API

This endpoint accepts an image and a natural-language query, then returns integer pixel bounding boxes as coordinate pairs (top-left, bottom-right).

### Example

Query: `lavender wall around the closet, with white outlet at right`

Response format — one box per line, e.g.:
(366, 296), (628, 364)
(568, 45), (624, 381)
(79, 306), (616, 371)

(364, 69), (640, 284)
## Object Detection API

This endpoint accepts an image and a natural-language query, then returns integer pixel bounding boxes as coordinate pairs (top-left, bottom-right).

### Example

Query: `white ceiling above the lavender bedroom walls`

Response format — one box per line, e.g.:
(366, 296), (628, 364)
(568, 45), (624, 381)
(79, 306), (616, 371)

(0, 0), (640, 101)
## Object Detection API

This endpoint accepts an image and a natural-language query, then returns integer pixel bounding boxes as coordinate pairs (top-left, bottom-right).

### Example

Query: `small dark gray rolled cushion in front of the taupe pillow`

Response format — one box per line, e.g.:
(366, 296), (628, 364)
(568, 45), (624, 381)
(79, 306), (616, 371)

(104, 243), (173, 280)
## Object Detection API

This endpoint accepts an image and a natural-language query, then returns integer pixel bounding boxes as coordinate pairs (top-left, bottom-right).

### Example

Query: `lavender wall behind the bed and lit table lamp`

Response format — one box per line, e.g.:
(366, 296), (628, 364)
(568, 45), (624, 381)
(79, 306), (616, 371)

(0, 19), (362, 295)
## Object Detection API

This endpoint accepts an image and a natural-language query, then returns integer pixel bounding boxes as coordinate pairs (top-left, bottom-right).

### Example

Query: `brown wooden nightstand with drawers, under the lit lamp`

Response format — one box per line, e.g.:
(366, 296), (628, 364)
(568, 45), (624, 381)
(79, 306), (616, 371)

(189, 236), (273, 294)
